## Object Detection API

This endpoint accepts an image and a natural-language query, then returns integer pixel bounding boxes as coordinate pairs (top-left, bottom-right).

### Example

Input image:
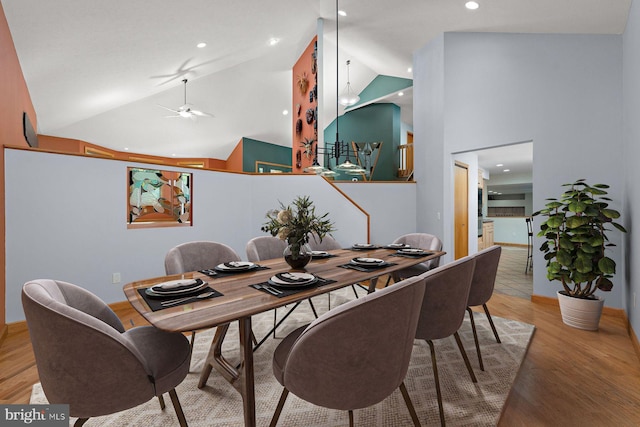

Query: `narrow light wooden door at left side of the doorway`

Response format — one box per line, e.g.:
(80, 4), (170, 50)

(453, 162), (469, 259)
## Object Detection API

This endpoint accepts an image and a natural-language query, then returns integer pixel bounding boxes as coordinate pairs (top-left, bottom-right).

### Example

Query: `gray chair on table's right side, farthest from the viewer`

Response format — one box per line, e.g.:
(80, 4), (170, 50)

(467, 245), (502, 371)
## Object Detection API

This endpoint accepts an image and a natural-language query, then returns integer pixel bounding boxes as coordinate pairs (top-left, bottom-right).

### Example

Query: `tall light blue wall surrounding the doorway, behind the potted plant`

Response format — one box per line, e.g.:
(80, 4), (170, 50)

(413, 33), (625, 308)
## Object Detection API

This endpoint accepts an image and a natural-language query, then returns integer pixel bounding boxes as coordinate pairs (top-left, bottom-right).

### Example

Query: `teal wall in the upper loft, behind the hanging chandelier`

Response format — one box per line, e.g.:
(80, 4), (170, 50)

(324, 104), (400, 181)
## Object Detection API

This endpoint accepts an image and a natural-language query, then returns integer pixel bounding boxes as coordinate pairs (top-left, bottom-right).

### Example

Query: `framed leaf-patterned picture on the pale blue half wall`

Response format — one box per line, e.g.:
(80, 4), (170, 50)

(127, 167), (192, 228)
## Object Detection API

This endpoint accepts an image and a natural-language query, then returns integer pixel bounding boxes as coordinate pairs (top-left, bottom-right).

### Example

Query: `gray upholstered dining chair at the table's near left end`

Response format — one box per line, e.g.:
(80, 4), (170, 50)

(22, 279), (191, 426)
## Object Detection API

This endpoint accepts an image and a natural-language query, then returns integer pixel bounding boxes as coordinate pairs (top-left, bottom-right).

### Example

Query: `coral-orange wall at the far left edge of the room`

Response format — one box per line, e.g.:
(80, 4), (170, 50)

(0, 4), (37, 342)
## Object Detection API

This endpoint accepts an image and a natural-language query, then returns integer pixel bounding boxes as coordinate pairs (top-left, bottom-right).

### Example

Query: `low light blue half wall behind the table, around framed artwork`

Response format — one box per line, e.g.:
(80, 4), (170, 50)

(5, 149), (416, 322)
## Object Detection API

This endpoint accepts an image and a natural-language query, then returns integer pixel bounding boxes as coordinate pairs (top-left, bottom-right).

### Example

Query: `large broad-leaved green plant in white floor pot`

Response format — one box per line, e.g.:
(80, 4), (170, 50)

(533, 179), (627, 330)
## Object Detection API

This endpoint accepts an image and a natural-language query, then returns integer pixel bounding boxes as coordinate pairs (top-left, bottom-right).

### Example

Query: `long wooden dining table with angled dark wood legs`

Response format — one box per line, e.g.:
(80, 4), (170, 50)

(123, 247), (445, 426)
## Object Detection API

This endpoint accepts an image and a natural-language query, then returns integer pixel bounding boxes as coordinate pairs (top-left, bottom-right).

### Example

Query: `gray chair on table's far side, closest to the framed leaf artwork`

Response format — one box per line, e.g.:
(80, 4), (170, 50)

(164, 240), (240, 348)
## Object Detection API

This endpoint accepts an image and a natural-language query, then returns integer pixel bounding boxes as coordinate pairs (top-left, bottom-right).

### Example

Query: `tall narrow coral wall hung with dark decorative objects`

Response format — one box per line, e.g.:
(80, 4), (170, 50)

(291, 36), (318, 173)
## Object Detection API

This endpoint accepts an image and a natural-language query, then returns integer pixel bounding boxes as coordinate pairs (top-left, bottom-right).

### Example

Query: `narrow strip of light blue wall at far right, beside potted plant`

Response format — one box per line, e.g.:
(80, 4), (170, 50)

(618, 0), (640, 342)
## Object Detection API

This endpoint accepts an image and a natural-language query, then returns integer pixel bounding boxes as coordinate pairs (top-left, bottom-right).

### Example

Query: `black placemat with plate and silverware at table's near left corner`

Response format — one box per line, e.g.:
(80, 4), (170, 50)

(138, 279), (222, 311)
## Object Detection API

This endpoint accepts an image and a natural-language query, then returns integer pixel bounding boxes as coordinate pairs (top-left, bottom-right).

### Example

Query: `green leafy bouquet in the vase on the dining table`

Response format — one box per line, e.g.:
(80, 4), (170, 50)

(261, 196), (335, 253)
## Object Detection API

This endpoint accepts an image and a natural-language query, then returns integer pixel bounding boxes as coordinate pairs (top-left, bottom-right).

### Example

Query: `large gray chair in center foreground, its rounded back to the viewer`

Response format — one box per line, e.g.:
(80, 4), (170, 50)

(271, 277), (425, 426)
